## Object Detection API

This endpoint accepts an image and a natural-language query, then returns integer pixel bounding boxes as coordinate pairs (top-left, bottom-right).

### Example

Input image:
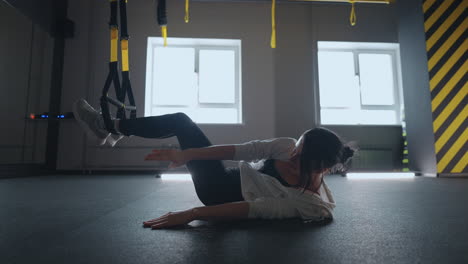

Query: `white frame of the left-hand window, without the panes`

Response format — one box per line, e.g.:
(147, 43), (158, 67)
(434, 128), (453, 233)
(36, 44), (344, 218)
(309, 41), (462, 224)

(145, 37), (244, 125)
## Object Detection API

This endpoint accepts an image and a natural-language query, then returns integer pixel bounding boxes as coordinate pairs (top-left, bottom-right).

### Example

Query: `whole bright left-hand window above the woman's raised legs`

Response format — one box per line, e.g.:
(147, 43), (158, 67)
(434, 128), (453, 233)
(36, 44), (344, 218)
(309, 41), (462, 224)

(145, 37), (242, 124)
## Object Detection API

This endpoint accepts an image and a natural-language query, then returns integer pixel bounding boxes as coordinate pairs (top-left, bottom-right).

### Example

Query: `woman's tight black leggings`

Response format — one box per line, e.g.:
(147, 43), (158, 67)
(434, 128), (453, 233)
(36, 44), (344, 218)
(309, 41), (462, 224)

(117, 113), (244, 205)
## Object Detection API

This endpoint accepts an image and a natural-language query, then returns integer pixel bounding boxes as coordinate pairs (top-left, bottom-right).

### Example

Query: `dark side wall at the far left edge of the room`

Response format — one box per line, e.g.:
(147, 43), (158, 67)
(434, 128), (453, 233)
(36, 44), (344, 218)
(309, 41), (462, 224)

(0, 1), (53, 165)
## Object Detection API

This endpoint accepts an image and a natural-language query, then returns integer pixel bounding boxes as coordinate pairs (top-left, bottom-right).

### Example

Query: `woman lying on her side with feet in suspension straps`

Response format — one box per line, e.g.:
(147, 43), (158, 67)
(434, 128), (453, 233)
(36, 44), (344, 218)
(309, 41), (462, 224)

(73, 99), (354, 229)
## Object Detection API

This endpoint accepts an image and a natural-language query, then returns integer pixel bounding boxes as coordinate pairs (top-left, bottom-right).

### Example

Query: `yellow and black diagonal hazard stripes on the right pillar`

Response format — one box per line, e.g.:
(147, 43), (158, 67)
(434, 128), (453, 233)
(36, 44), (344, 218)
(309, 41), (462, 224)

(423, 0), (468, 173)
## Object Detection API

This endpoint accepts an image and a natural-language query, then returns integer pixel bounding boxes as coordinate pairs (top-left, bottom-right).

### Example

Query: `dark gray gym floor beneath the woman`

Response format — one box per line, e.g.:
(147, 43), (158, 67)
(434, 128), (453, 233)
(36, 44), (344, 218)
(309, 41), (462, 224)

(0, 175), (468, 264)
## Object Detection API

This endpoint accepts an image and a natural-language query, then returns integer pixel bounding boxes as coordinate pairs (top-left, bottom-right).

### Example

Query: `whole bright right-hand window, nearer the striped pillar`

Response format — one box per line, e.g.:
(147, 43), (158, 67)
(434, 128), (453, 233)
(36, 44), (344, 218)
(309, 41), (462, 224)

(318, 41), (402, 125)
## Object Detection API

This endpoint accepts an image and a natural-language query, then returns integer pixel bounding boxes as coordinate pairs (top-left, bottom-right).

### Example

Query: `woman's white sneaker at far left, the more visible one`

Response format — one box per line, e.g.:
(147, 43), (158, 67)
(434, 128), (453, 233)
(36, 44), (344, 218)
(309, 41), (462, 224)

(73, 99), (110, 145)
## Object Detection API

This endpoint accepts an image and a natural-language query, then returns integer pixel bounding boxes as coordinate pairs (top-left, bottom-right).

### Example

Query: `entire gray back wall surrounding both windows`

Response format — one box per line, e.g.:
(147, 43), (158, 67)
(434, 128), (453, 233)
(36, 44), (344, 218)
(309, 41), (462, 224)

(58, 0), (400, 169)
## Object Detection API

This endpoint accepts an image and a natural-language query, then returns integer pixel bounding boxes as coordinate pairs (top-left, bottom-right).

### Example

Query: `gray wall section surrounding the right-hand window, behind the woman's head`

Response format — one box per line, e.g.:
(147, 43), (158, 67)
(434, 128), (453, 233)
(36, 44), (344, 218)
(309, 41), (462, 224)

(275, 3), (401, 167)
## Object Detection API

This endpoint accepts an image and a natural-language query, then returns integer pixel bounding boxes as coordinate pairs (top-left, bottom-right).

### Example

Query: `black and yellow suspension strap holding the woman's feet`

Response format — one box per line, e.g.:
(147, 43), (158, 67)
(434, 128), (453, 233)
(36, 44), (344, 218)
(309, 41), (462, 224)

(100, 0), (136, 134)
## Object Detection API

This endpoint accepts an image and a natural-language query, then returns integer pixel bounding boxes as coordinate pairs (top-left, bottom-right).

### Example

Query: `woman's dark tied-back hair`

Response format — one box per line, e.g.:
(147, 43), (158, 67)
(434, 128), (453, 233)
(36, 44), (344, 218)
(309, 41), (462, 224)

(294, 127), (354, 193)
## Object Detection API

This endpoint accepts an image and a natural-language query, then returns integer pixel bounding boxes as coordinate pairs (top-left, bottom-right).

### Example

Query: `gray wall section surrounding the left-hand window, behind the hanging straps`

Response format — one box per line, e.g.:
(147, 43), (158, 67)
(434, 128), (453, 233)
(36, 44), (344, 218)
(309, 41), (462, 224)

(58, 0), (275, 169)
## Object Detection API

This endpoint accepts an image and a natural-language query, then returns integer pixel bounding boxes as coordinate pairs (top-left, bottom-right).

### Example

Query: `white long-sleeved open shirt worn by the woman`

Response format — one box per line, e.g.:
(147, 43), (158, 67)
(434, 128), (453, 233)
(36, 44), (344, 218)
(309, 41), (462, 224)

(234, 138), (335, 221)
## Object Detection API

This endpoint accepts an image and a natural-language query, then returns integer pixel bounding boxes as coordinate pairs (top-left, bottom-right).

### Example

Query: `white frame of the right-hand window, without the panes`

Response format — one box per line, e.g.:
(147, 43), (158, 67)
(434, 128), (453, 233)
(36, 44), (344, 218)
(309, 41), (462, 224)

(315, 41), (403, 126)
